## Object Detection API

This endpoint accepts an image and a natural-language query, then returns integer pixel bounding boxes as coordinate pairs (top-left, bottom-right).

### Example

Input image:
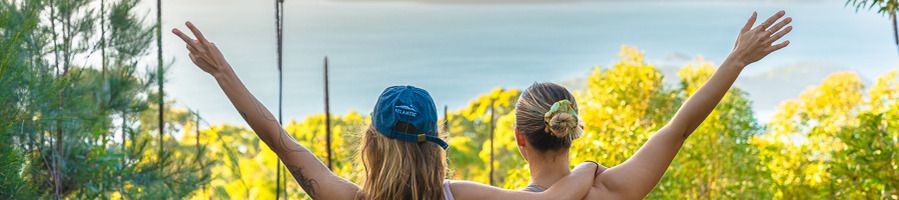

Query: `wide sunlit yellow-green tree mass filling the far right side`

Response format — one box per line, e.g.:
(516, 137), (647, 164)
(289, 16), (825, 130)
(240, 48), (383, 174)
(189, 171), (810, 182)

(753, 72), (899, 199)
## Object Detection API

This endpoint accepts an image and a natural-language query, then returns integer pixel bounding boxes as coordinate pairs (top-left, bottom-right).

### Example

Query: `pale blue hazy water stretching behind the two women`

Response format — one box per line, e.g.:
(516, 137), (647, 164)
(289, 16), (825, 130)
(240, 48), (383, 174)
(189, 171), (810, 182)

(151, 0), (899, 124)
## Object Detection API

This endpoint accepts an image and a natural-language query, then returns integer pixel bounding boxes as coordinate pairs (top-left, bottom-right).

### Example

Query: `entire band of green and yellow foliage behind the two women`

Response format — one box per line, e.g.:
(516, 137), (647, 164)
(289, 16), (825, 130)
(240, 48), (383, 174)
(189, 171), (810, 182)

(0, 0), (899, 199)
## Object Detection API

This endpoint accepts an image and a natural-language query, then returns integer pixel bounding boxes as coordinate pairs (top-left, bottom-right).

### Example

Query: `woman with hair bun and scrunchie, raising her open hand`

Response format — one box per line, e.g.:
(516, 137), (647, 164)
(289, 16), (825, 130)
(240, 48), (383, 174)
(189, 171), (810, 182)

(515, 11), (793, 199)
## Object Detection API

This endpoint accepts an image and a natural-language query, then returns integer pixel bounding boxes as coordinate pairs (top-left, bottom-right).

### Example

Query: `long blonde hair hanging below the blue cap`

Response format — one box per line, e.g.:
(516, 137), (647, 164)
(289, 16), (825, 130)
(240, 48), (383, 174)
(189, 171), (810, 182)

(360, 127), (446, 200)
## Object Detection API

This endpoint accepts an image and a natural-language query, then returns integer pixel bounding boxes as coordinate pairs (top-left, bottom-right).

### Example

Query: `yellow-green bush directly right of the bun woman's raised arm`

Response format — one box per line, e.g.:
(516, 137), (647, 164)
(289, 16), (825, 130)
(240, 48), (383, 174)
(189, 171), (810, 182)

(650, 60), (771, 199)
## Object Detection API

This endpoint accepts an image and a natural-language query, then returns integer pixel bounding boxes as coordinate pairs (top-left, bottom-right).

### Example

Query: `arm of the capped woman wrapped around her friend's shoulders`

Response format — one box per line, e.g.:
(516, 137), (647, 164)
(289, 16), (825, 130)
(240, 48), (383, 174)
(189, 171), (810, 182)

(450, 162), (599, 200)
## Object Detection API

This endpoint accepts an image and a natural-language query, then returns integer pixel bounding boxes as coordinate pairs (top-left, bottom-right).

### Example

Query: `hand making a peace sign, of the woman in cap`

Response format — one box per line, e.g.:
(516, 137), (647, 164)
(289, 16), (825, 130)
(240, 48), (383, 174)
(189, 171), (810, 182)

(172, 22), (233, 77)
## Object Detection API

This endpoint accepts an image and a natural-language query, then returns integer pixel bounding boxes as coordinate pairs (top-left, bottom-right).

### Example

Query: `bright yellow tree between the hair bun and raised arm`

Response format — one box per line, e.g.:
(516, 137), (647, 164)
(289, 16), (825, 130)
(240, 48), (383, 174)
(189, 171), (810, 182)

(571, 46), (683, 167)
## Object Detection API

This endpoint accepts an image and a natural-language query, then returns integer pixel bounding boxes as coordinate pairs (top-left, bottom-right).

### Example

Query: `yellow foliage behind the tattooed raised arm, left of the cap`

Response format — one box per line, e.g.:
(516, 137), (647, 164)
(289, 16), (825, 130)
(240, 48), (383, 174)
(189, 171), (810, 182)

(181, 112), (368, 199)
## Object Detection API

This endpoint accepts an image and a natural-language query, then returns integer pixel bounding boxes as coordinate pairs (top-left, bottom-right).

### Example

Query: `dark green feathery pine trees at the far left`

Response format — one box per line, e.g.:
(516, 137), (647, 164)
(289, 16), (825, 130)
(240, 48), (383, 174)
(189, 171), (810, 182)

(0, 0), (208, 199)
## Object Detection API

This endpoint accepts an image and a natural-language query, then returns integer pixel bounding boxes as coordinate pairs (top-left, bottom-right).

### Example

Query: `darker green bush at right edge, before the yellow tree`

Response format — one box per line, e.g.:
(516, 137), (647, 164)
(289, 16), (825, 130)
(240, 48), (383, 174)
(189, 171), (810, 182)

(831, 71), (899, 199)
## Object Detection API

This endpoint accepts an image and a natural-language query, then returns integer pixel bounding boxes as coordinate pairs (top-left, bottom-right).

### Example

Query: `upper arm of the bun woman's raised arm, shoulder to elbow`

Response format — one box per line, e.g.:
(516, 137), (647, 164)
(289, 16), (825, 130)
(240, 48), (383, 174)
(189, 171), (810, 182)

(594, 126), (684, 199)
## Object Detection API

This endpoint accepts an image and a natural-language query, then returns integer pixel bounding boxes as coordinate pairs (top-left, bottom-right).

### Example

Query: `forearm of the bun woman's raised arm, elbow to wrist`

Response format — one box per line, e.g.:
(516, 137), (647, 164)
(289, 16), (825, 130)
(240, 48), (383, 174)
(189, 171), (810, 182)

(660, 56), (746, 138)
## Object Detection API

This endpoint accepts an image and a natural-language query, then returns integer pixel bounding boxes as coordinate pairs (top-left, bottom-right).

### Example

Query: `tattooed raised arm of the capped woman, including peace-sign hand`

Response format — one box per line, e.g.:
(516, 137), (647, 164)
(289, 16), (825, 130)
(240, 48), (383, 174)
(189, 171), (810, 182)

(172, 22), (359, 199)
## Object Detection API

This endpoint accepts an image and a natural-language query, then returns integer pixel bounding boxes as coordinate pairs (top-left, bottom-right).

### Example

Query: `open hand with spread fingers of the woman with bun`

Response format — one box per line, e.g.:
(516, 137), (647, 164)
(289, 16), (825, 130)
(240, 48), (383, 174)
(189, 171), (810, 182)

(729, 11), (793, 66)
